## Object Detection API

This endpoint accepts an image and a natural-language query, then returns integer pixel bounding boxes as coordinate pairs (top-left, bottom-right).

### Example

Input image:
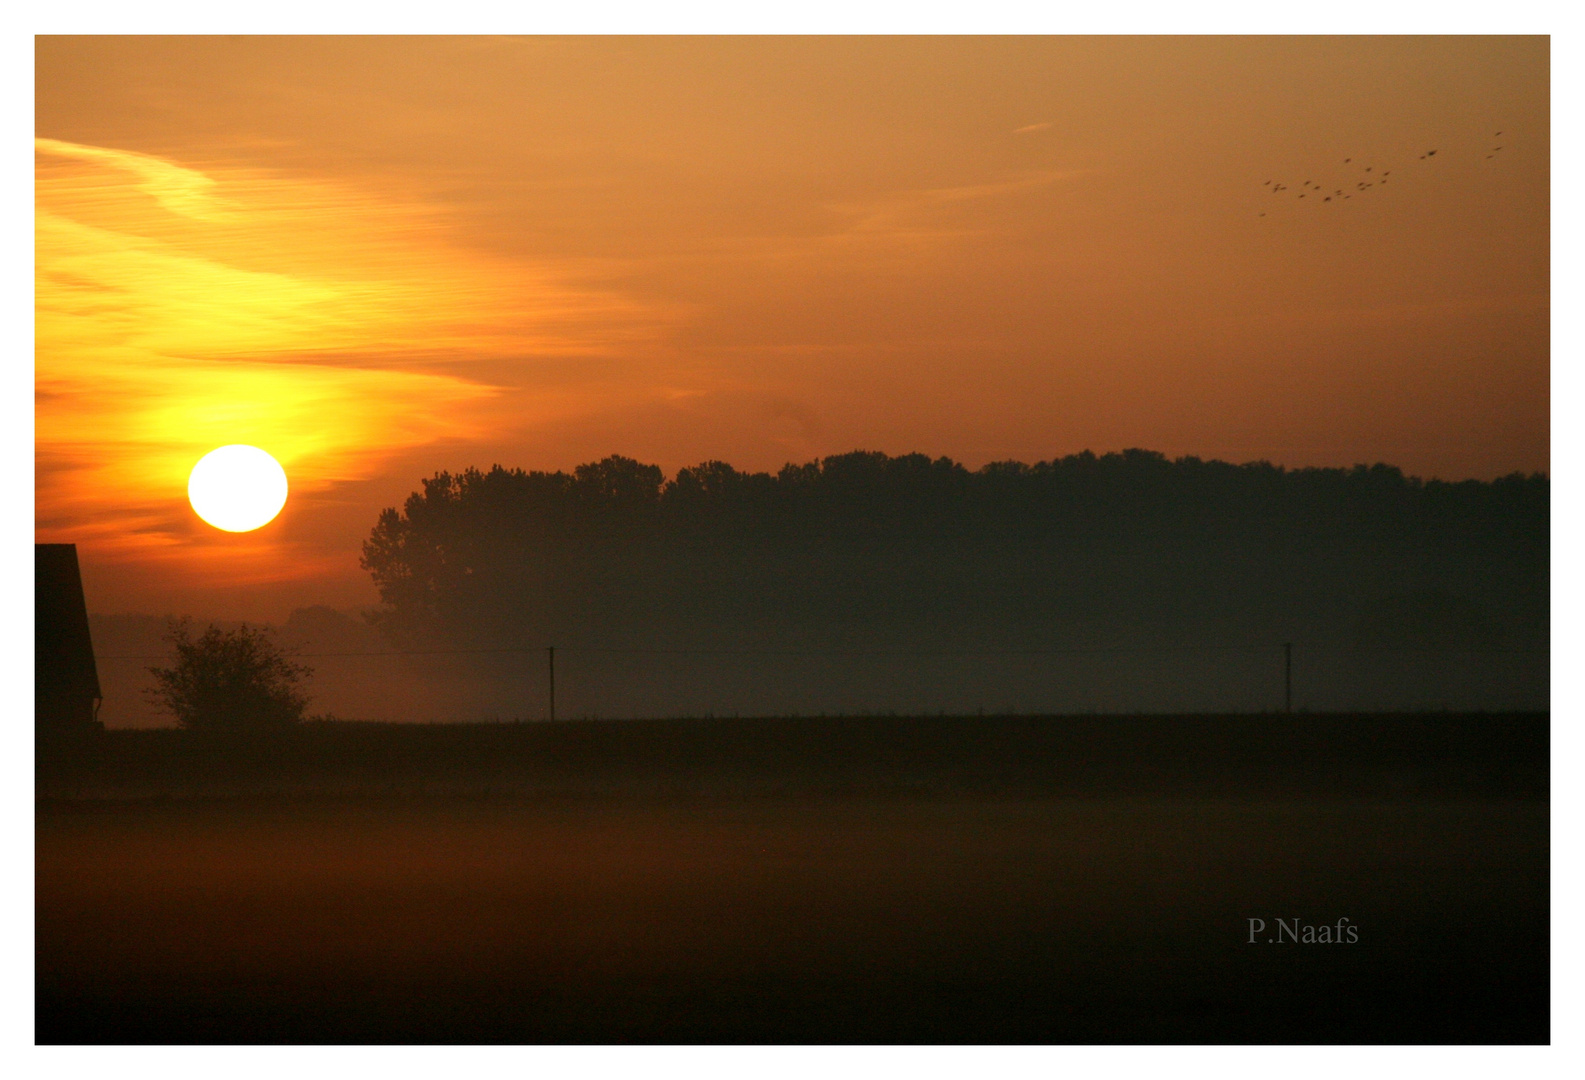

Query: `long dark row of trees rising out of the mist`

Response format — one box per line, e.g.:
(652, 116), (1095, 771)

(363, 450), (1550, 666)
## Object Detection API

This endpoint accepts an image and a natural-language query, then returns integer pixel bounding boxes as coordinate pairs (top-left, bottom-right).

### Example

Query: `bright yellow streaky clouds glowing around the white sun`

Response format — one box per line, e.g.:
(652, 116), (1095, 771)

(35, 140), (661, 579)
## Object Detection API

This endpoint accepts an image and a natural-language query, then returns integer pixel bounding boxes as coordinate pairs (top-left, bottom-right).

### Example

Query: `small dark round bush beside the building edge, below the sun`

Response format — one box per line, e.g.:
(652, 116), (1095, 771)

(147, 619), (312, 734)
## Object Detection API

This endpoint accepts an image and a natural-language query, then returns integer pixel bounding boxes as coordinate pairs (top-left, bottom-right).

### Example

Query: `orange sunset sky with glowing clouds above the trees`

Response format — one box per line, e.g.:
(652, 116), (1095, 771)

(36, 36), (1550, 619)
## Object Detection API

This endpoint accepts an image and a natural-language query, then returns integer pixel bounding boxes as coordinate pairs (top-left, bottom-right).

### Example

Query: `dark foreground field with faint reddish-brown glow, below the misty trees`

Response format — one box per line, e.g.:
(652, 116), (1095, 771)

(36, 714), (1549, 1044)
